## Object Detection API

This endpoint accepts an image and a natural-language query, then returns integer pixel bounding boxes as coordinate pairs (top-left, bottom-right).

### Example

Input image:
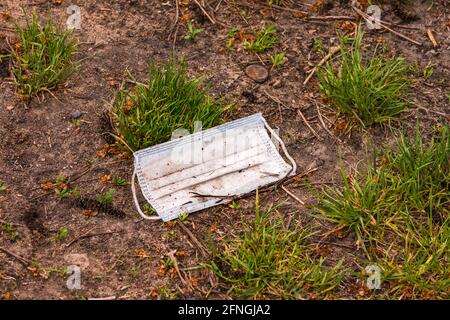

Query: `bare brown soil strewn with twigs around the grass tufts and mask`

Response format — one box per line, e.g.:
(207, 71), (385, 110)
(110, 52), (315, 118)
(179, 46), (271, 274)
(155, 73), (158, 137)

(0, 0), (450, 299)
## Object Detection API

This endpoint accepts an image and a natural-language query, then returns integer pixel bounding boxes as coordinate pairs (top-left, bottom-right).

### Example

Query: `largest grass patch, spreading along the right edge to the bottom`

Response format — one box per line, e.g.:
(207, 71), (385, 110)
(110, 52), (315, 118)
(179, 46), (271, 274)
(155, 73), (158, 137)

(317, 126), (450, 298)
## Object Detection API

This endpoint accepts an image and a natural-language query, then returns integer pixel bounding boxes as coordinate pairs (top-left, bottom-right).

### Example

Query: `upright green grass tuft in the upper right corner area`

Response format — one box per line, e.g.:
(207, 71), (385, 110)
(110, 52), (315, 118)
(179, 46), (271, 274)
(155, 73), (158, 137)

(317, 30), (410, 126)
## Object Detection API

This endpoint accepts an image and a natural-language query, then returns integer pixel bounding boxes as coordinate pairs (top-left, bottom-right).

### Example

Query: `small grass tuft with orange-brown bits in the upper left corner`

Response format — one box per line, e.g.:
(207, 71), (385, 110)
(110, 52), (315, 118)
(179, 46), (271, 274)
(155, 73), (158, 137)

(11, 14), (78, 98)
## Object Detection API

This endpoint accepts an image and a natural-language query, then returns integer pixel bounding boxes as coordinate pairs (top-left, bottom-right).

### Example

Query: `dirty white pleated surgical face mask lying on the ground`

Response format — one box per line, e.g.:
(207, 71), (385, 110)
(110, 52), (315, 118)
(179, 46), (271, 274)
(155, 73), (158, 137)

(132, 113), (297, 221)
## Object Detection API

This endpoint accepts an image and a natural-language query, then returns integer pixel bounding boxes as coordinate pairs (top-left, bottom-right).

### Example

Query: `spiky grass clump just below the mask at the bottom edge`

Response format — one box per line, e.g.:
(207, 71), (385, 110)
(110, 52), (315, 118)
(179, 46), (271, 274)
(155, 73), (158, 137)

(209, 192), (343, 299)
